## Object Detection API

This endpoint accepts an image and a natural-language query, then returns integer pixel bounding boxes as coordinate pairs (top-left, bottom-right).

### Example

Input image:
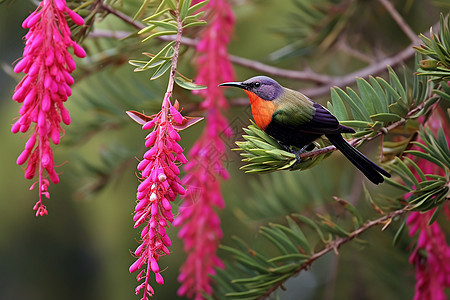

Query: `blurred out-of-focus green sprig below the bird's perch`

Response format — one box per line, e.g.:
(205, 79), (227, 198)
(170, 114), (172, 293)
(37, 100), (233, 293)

(237, 160), (354, 222)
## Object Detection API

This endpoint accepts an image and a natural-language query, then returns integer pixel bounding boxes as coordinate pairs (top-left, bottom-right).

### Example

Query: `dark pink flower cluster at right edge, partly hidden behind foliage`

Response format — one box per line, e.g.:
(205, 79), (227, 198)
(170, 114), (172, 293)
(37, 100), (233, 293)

(407, 111), (450, 300)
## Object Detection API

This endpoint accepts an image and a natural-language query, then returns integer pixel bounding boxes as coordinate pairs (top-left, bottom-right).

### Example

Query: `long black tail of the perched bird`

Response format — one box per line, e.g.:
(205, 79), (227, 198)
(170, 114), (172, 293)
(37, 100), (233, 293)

(326, 134), (391, 184)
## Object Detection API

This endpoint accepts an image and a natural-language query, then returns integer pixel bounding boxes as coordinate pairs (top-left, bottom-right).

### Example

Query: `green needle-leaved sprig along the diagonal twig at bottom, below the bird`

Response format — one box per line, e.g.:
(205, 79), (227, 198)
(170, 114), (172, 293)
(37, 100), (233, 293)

(214, 203), (404, 299)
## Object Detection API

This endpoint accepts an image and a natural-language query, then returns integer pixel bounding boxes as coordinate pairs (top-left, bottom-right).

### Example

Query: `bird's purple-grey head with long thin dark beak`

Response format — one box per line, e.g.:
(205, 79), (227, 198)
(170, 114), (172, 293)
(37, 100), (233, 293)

(219, 76), (283, 101)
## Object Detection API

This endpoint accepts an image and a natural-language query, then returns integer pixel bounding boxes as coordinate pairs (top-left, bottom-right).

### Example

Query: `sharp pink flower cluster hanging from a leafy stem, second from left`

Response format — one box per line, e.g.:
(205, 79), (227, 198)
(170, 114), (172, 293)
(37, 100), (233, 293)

(129, 94), (187, 300)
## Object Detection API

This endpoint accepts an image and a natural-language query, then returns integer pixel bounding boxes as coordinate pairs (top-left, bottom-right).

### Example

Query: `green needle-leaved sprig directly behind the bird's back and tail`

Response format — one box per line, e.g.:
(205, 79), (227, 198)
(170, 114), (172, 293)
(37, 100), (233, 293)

(328, 65), (438, 138)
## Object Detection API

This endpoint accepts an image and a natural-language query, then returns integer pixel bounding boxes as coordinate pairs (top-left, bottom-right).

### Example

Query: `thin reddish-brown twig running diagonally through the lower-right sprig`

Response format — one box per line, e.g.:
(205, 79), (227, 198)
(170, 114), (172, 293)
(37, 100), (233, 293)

(259, 206), (409, 299)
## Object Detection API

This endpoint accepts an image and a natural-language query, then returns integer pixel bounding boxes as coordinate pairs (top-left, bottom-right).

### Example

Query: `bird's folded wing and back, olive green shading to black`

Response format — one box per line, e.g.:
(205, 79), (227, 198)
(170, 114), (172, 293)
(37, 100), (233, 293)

(272, 90), (339, 134)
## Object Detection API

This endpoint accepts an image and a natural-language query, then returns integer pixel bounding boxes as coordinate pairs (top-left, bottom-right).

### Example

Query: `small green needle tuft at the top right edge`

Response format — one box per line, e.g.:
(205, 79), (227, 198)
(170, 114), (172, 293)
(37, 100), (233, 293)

(414, 14), (450, 81)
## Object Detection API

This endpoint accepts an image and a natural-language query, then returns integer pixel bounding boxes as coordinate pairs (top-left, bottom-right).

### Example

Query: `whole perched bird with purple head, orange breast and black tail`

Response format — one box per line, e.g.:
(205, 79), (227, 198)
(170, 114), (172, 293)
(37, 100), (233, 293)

(219, 76), (391, 184)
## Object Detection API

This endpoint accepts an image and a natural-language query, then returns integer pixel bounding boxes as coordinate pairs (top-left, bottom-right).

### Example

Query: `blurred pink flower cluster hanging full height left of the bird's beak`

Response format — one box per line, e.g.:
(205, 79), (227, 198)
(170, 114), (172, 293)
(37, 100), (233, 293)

(174, 0), (234, 299)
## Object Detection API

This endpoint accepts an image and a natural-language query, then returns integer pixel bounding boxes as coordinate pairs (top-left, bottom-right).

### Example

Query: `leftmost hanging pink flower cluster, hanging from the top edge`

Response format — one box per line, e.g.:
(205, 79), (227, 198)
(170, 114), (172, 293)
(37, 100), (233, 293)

(11, 0), (86, 216)
